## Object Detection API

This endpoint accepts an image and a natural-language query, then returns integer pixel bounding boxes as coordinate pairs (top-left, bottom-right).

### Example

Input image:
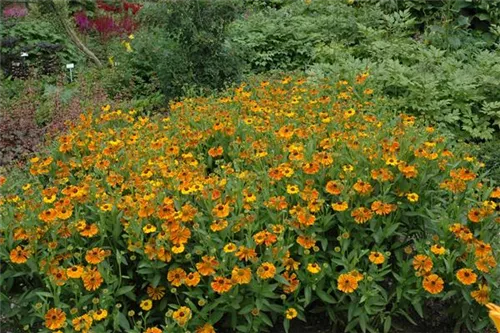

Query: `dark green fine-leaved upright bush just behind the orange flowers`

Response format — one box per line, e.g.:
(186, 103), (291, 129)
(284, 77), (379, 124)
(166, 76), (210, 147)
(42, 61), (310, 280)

(130, 0), (244, 99)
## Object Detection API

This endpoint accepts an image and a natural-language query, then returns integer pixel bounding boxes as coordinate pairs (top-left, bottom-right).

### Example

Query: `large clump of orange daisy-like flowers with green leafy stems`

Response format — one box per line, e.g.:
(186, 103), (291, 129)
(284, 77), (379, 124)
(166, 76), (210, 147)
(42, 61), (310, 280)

(0, 73), (500, 333)
